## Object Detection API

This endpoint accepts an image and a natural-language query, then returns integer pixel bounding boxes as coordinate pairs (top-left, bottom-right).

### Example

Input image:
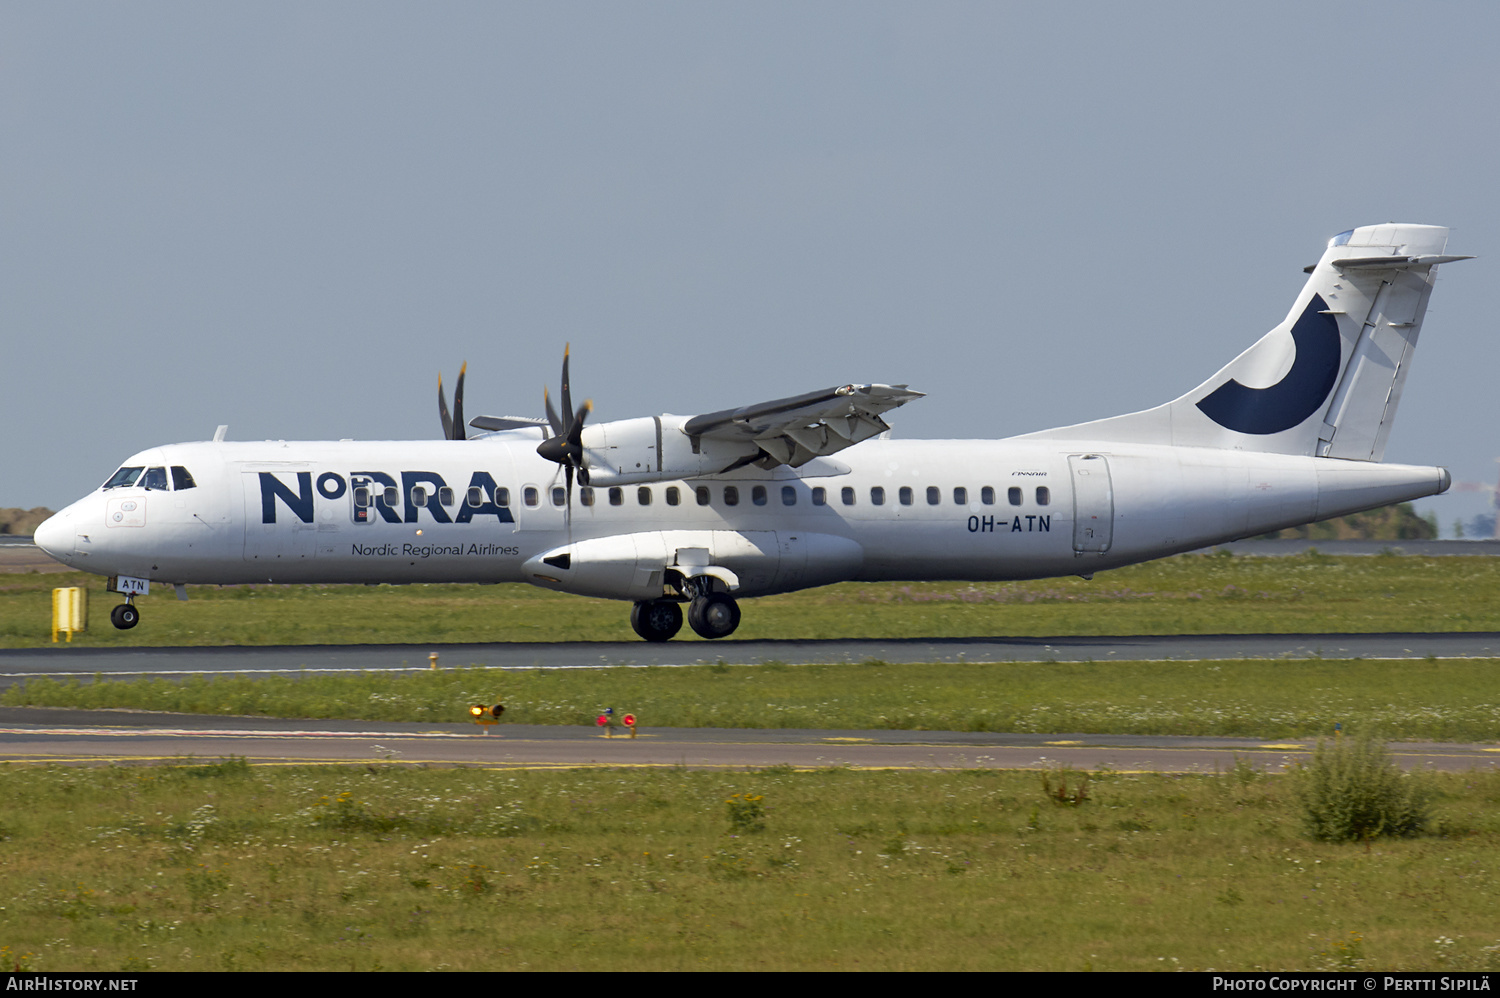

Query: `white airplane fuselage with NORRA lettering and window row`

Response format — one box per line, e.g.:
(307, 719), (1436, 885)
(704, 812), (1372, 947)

(38, 431), (1448, 600)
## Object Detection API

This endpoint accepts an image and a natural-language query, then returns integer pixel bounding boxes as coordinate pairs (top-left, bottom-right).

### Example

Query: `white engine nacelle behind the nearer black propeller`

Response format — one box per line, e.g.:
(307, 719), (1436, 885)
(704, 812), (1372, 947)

(584, 416), (761, 486)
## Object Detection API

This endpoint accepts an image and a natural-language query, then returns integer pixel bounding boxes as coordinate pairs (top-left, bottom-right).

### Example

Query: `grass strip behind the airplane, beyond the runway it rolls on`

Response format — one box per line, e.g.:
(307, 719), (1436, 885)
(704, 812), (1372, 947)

(0, 554), (1500, 657)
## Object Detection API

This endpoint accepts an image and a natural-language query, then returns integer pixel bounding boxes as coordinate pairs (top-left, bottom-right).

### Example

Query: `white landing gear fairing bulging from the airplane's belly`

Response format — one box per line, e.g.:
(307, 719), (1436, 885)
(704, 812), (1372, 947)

(524, 530), (864, 600)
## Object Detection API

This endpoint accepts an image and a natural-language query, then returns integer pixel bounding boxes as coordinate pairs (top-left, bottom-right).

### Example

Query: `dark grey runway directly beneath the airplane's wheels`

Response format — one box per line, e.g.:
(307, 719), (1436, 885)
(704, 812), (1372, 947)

(0, 632), (1500, 689)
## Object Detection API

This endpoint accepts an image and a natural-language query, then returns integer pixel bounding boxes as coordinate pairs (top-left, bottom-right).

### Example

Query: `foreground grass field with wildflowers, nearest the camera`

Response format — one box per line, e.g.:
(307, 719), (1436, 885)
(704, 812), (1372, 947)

(0, 761), (1500, 972)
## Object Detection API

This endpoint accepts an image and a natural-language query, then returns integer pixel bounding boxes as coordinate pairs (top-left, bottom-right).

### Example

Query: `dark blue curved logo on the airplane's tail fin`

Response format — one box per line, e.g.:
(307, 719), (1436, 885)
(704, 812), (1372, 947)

(1199, 294), (1341, 435)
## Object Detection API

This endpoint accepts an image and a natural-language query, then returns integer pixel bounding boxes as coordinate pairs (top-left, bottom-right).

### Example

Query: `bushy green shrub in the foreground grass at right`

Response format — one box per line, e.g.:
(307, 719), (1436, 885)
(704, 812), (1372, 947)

(1298, 734), (1433, 842)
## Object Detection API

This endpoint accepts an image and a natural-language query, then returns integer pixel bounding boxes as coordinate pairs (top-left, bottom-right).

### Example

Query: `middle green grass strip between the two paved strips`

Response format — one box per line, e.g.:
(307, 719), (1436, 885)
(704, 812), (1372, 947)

(11, 659), (1500, 741)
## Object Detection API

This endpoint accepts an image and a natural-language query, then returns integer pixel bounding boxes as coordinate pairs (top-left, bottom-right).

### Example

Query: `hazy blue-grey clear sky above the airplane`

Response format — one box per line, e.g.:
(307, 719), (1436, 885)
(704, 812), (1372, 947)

(0, 0), (1500, 533)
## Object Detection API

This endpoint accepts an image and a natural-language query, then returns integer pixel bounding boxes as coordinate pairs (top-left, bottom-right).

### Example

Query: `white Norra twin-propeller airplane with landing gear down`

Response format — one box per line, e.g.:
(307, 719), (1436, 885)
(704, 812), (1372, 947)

(35, 224), (1470, 641)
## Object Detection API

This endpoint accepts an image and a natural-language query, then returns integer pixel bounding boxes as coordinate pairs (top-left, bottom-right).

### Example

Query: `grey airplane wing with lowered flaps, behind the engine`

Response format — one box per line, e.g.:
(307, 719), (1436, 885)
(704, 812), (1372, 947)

(683, 384), (923, 468)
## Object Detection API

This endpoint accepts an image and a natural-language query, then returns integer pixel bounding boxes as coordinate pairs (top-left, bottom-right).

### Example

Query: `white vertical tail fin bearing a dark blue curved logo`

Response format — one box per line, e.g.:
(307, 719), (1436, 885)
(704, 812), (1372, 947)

(1028, 224), (1467, 461)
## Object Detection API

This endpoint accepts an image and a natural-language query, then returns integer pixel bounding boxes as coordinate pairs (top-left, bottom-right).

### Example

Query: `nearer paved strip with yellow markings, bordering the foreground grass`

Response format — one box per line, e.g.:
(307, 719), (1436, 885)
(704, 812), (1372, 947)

(0, 707), (1500, 773)
